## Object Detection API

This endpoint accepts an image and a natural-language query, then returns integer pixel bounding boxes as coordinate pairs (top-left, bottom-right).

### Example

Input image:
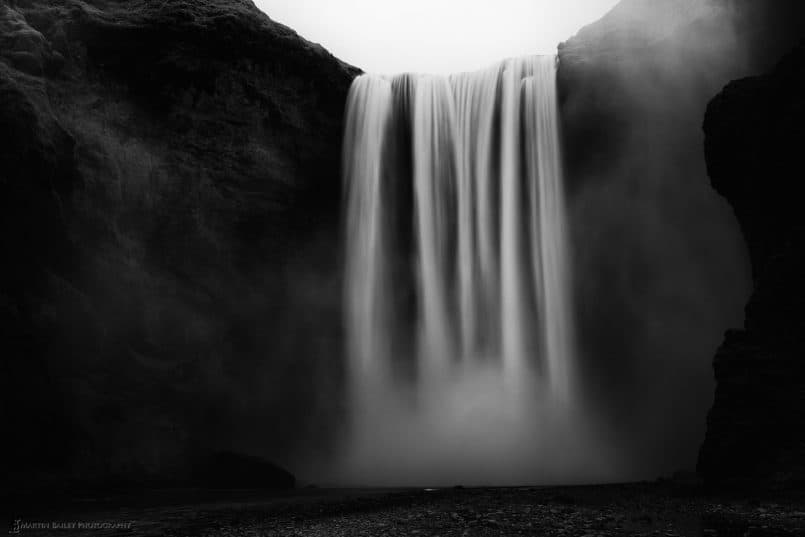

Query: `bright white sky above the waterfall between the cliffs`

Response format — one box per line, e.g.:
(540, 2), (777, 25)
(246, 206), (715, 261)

(255, 0), (617, 74)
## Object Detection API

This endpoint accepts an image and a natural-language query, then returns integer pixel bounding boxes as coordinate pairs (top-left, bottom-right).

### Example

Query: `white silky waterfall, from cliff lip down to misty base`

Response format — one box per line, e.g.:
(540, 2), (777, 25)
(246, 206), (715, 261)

(336, 57), (612, 485)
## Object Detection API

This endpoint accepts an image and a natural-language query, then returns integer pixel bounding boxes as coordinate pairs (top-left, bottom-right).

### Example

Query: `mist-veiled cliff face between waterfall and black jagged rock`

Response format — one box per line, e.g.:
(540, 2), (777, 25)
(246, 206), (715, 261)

(559, 0), (805, 477)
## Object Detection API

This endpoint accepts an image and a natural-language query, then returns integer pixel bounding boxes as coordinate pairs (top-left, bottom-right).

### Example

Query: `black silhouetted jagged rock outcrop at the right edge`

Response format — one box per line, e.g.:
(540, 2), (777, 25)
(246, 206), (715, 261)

(699, 44), (805, 483)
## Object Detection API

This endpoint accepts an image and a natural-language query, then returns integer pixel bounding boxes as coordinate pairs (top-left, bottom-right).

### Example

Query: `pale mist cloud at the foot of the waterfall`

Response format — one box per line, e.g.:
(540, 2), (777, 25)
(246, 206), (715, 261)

(327, 365), (628, 487)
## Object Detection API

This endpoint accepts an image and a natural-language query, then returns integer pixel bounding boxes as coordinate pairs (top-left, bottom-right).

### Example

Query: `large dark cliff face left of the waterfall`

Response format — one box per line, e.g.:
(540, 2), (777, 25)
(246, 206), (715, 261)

(0, 0), (357, 481)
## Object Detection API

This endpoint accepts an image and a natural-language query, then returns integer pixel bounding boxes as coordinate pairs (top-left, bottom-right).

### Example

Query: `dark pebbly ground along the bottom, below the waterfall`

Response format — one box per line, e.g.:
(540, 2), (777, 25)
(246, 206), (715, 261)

(6, 484), (805, 537)
